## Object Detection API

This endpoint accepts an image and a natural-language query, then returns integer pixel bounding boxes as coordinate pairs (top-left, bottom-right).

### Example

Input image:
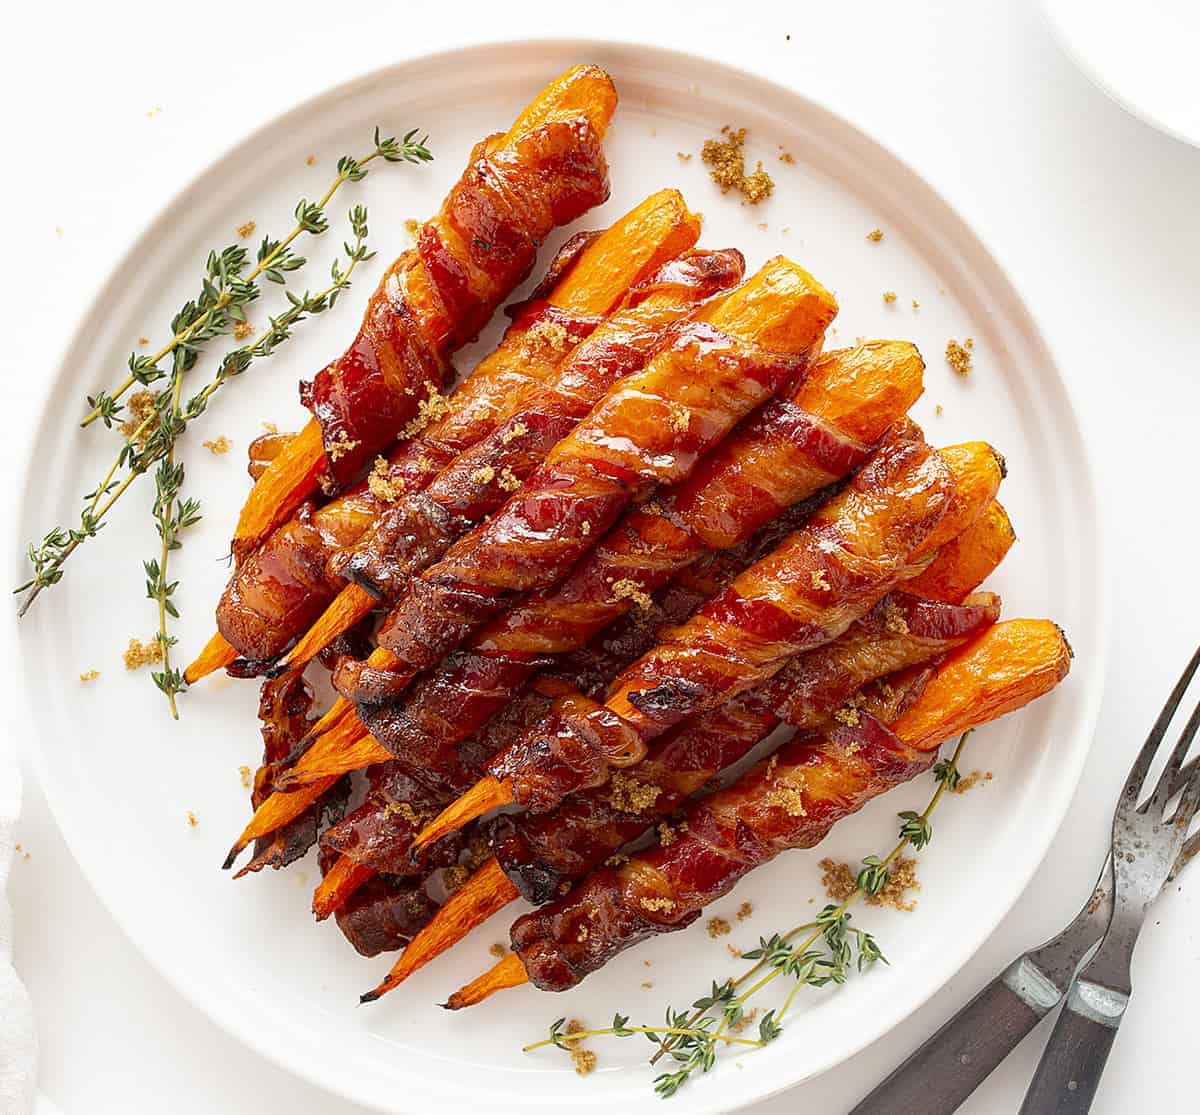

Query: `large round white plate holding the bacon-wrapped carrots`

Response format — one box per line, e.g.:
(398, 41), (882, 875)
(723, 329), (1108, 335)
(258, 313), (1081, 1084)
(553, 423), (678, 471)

(19, 43), (1104, 1111)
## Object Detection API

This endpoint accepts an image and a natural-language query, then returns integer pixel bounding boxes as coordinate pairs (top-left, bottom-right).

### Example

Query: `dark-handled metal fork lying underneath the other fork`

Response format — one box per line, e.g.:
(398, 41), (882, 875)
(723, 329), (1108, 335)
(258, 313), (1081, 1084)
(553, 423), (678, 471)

(851, 651), (1200, 1115)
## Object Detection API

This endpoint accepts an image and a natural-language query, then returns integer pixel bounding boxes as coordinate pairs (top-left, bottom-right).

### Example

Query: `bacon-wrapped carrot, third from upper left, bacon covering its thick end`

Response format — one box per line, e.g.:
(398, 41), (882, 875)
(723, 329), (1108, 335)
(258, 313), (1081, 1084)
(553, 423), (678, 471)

(283, 250), (744, 670)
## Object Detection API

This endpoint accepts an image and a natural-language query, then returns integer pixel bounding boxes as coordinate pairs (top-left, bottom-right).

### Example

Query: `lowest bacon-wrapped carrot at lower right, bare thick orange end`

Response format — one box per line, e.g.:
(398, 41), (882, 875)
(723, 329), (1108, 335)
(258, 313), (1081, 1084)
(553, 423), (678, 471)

(448, 619), (1070, 1008)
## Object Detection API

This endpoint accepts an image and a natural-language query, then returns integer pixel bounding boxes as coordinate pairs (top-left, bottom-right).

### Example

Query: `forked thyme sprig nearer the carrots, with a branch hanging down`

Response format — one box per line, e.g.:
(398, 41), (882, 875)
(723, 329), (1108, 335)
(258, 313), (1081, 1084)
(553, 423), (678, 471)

(13, 205), (374, 619)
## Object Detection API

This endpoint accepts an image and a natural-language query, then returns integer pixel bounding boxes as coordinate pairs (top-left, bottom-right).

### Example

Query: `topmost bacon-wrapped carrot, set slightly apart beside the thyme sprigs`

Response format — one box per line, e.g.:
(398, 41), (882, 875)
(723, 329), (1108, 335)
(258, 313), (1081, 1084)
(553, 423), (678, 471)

(234, 66), (617, 561)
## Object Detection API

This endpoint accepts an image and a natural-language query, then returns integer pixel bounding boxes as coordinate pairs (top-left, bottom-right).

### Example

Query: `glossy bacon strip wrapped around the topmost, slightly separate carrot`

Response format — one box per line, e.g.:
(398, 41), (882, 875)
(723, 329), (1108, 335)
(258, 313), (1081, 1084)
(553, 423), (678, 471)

(301, 118), (608, 486)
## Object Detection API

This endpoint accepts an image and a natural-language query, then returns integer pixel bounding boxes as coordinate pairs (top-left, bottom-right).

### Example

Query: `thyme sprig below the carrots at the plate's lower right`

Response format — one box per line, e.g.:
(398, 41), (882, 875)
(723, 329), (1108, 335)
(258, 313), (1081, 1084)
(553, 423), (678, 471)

(523, 731), (971, 1099)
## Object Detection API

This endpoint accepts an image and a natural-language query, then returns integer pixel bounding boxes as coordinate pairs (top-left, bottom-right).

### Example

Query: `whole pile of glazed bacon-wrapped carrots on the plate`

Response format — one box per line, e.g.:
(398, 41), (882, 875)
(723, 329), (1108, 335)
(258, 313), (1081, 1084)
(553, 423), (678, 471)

(187, 66), (1069, 1006)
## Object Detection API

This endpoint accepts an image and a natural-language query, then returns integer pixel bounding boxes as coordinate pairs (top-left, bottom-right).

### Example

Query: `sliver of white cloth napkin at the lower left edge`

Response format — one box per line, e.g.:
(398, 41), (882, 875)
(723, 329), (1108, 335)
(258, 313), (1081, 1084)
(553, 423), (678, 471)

(0, 737), (37, 1115)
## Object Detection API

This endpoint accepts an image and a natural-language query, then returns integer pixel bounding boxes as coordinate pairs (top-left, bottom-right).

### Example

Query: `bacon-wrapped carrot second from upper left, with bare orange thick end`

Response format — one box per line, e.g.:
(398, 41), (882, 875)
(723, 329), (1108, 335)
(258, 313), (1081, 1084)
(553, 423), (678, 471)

(188, 190), (700, 682)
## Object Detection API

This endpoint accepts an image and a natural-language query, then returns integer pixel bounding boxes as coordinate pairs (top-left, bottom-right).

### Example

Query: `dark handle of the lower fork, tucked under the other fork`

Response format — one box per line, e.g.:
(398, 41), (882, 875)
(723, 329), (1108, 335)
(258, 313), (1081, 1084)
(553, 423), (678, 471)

(851, 957), (1061, 1115)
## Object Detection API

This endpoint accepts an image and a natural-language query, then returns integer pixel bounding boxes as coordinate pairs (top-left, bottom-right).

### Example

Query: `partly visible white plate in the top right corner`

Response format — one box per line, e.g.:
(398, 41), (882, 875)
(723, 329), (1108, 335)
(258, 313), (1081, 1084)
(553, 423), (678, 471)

(1045, 0), (1200, 146)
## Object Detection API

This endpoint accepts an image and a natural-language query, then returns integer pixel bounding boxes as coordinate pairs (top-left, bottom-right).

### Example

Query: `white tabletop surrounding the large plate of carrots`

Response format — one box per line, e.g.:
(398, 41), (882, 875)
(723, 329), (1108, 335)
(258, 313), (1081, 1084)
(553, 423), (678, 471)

(5, 5), (1200, 1115)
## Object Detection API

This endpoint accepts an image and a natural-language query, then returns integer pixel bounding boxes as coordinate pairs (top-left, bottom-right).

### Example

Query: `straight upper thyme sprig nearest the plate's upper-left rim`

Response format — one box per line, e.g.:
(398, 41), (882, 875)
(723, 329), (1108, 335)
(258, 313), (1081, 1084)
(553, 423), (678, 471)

(79, 128), (433, 426)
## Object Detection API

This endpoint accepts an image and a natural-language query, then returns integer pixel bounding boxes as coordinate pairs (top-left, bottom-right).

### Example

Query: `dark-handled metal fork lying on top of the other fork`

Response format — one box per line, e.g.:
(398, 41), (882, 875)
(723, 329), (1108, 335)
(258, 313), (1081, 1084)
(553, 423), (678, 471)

(1020, 651), (1200, 1115)
